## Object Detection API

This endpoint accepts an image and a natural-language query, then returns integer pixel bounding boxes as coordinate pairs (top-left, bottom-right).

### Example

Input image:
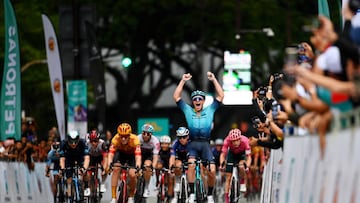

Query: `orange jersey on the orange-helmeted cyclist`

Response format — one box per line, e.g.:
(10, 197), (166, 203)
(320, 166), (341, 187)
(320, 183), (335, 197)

(109, 134), (141, 156)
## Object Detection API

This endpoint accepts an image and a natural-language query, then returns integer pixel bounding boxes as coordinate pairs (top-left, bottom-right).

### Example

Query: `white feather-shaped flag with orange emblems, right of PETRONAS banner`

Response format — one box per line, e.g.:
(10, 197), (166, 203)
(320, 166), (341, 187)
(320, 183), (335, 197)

(41, 14), (65, 140)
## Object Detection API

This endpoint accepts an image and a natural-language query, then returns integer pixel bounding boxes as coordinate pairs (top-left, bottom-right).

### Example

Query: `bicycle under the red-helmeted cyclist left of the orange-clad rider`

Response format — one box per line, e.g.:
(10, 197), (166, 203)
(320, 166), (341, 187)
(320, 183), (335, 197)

(87, 164), (103, 203)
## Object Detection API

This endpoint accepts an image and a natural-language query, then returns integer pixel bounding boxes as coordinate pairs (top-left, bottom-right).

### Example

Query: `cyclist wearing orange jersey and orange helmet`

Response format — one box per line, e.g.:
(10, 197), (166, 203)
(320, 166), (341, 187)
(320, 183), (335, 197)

(106, 123), (141, 203)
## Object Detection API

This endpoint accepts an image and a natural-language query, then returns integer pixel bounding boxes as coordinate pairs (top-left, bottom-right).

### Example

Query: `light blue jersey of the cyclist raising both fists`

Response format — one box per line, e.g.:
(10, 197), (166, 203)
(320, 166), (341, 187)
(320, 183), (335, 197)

(177, 99), (222, 140)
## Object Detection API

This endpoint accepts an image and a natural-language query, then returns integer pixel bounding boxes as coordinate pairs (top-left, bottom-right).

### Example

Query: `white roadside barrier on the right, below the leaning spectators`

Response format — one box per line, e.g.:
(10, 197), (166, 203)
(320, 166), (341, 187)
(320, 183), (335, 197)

(261, 108), (360, 203)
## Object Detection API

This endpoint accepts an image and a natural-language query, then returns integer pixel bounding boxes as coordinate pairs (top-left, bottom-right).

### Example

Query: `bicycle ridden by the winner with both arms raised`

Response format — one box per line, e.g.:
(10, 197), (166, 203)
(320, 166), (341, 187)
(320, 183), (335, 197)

(190, 159), (208, 203)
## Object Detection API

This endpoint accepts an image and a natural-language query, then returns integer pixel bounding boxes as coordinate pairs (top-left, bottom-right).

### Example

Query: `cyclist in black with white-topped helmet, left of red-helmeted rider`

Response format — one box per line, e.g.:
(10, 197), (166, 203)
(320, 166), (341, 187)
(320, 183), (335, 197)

(60, 131), (90, 196)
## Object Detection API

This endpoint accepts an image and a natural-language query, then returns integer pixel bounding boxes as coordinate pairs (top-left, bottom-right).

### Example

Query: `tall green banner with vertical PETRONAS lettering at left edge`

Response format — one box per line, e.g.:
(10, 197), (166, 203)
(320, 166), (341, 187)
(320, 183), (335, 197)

(0, 0), (21, 140)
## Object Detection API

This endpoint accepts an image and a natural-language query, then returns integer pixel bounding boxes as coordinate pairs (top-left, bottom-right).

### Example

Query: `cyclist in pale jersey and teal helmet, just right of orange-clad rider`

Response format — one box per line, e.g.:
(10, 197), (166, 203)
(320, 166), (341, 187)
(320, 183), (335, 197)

(138, 123), (160, 197)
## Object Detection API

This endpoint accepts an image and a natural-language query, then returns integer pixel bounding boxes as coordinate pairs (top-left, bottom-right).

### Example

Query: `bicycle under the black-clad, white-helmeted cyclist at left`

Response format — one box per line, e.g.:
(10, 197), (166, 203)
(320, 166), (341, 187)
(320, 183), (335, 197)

(64, 165), (84, 203)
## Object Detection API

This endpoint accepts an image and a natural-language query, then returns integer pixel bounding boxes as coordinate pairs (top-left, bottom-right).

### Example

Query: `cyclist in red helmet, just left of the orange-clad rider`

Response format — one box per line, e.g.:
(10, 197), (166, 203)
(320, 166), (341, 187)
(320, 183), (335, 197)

(84, 130), (108, 196)
